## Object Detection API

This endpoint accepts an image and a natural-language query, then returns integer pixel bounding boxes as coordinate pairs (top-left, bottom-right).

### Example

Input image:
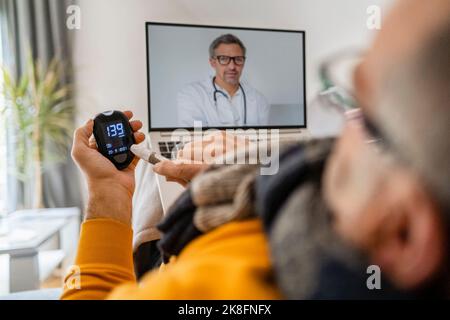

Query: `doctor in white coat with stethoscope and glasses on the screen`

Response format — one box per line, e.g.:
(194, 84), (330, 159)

(177, 34), (270, 127)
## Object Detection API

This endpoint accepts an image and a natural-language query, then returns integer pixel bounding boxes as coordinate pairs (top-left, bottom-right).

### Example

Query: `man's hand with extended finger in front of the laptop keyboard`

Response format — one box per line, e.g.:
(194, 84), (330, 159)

(153, 131), (249, 186)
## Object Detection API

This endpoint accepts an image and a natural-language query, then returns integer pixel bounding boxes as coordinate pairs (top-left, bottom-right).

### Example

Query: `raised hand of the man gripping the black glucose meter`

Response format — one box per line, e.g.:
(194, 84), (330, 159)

(72, 111), (145, 225)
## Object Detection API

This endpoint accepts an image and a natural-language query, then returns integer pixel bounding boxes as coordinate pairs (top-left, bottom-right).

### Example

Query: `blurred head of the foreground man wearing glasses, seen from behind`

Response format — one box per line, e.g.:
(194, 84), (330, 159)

(324, 0), (450, 291)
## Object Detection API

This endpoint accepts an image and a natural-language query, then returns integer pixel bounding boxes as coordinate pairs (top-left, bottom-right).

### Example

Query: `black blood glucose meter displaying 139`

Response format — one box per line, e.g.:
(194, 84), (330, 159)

(94, 111), (135, 170)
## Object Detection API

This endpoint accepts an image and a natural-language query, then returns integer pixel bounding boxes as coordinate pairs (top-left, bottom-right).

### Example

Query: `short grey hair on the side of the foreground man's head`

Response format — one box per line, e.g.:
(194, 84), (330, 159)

(377, 21), (450, 215)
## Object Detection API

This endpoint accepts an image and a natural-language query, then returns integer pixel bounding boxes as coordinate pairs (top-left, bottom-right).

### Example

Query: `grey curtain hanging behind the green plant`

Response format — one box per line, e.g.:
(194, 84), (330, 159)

(0, 0), (81, 211)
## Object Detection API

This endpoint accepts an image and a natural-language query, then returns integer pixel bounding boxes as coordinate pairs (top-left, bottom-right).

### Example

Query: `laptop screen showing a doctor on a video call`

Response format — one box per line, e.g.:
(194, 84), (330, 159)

(146, 22), (306, 131)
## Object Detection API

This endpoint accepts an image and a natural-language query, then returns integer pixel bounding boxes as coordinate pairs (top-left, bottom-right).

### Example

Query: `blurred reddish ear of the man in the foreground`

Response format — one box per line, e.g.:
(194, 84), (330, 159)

(372, 172), (447, 289)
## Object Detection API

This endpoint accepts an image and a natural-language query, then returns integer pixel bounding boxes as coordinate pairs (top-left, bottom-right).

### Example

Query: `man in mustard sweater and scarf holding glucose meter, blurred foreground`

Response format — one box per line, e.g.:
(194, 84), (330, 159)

(63, 0), (450, 299)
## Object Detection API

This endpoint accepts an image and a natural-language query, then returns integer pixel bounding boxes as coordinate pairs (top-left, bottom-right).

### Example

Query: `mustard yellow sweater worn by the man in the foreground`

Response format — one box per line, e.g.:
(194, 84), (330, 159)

(61, 219), (281, 299)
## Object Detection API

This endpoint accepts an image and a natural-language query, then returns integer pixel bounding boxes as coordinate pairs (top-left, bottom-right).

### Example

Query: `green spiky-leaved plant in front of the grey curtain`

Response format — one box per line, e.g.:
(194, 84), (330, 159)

(1, 57), (74, 208)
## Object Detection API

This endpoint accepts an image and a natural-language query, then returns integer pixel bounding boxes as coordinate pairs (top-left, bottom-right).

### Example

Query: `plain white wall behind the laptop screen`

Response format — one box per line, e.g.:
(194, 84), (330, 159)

(74, 0), (392, 136)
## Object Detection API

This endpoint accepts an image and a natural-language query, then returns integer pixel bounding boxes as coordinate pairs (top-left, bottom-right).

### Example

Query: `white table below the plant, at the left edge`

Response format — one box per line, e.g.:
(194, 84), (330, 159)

(0, 208), (80, 292)
